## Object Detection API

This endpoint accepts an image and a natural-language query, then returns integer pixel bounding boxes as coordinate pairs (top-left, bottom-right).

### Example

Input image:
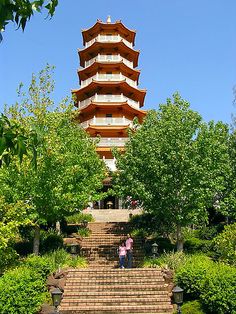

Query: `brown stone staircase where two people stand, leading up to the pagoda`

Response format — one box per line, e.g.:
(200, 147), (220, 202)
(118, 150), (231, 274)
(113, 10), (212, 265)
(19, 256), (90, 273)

(60, 223), (173, 314)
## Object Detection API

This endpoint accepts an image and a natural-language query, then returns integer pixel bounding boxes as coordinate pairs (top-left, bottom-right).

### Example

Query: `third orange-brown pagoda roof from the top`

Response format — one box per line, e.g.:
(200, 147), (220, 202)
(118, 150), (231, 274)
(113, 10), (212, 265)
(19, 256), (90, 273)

(77, 61), (140, 84)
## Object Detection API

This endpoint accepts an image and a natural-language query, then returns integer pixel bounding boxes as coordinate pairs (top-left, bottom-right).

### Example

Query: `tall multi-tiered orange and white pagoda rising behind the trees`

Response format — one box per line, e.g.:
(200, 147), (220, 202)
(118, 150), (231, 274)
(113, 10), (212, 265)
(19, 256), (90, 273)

(72, 17), (146, 208)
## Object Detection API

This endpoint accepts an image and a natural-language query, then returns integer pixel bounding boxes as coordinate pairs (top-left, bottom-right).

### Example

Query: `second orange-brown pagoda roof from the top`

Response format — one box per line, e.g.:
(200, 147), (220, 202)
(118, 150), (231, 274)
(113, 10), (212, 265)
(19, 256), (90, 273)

(78, 40), (139, 67)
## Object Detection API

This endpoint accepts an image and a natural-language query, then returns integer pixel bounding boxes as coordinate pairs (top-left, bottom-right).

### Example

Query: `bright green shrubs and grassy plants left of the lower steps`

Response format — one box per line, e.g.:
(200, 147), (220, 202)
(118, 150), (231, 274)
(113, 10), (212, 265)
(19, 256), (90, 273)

(0, 250), (86, 314)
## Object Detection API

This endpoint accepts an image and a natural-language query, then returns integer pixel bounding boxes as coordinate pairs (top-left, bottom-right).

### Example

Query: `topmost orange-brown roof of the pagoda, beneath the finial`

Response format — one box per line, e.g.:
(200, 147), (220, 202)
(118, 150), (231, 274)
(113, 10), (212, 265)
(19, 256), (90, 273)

(82, 20), (136, 45)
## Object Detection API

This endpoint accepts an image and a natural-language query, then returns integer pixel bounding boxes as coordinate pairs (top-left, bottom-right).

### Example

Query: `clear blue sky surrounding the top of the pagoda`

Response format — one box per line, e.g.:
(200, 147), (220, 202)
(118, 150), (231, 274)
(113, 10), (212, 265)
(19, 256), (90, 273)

(0, 0), (236, 123)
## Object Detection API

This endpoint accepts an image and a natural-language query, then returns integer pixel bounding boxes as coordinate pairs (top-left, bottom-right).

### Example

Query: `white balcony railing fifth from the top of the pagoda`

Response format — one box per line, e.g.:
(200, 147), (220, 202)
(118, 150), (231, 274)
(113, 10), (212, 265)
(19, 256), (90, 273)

(81, 117), (133, 128)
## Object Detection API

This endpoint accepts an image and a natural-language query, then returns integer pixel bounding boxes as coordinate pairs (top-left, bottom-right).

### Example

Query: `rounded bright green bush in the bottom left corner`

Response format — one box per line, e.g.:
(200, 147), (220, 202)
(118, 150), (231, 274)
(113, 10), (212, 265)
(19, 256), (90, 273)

(0, 267), (47, 314)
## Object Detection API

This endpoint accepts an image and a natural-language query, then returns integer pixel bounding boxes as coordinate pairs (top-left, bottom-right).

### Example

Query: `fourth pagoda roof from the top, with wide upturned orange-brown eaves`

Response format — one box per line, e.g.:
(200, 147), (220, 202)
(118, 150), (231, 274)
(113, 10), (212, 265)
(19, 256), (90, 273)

(71, 80), (146, 107)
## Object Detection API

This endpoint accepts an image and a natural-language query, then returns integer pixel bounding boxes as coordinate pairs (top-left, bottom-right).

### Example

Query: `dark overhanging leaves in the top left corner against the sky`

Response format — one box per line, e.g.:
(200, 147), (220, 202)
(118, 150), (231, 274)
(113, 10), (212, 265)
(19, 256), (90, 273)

(0, 0), (58, 40)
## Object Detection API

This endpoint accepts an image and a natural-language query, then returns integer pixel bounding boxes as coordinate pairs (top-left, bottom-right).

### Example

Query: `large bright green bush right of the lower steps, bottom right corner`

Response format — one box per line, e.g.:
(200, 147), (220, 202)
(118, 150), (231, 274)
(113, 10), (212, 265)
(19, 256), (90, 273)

(175, 255), (236, 314)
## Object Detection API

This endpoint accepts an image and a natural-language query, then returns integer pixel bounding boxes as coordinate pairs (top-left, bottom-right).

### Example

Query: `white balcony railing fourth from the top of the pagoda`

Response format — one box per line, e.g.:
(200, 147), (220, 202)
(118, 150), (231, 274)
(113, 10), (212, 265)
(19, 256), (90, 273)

(78, 94), (139, 109)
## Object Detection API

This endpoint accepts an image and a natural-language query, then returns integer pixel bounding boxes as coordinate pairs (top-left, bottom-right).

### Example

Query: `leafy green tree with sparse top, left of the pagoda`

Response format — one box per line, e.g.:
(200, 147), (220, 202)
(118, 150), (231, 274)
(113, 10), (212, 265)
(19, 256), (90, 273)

(0, 66), (105, 254)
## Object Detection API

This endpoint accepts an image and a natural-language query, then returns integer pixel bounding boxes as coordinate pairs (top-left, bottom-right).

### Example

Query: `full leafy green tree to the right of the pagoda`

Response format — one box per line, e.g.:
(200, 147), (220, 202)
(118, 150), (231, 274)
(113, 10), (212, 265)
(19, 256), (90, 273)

(116, 94), (229, 250)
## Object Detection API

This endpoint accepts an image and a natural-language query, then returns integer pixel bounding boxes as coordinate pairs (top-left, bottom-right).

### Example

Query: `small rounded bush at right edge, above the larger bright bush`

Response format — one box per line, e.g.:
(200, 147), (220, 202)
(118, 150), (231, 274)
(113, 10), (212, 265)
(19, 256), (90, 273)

(213, 223), (236, 265)
